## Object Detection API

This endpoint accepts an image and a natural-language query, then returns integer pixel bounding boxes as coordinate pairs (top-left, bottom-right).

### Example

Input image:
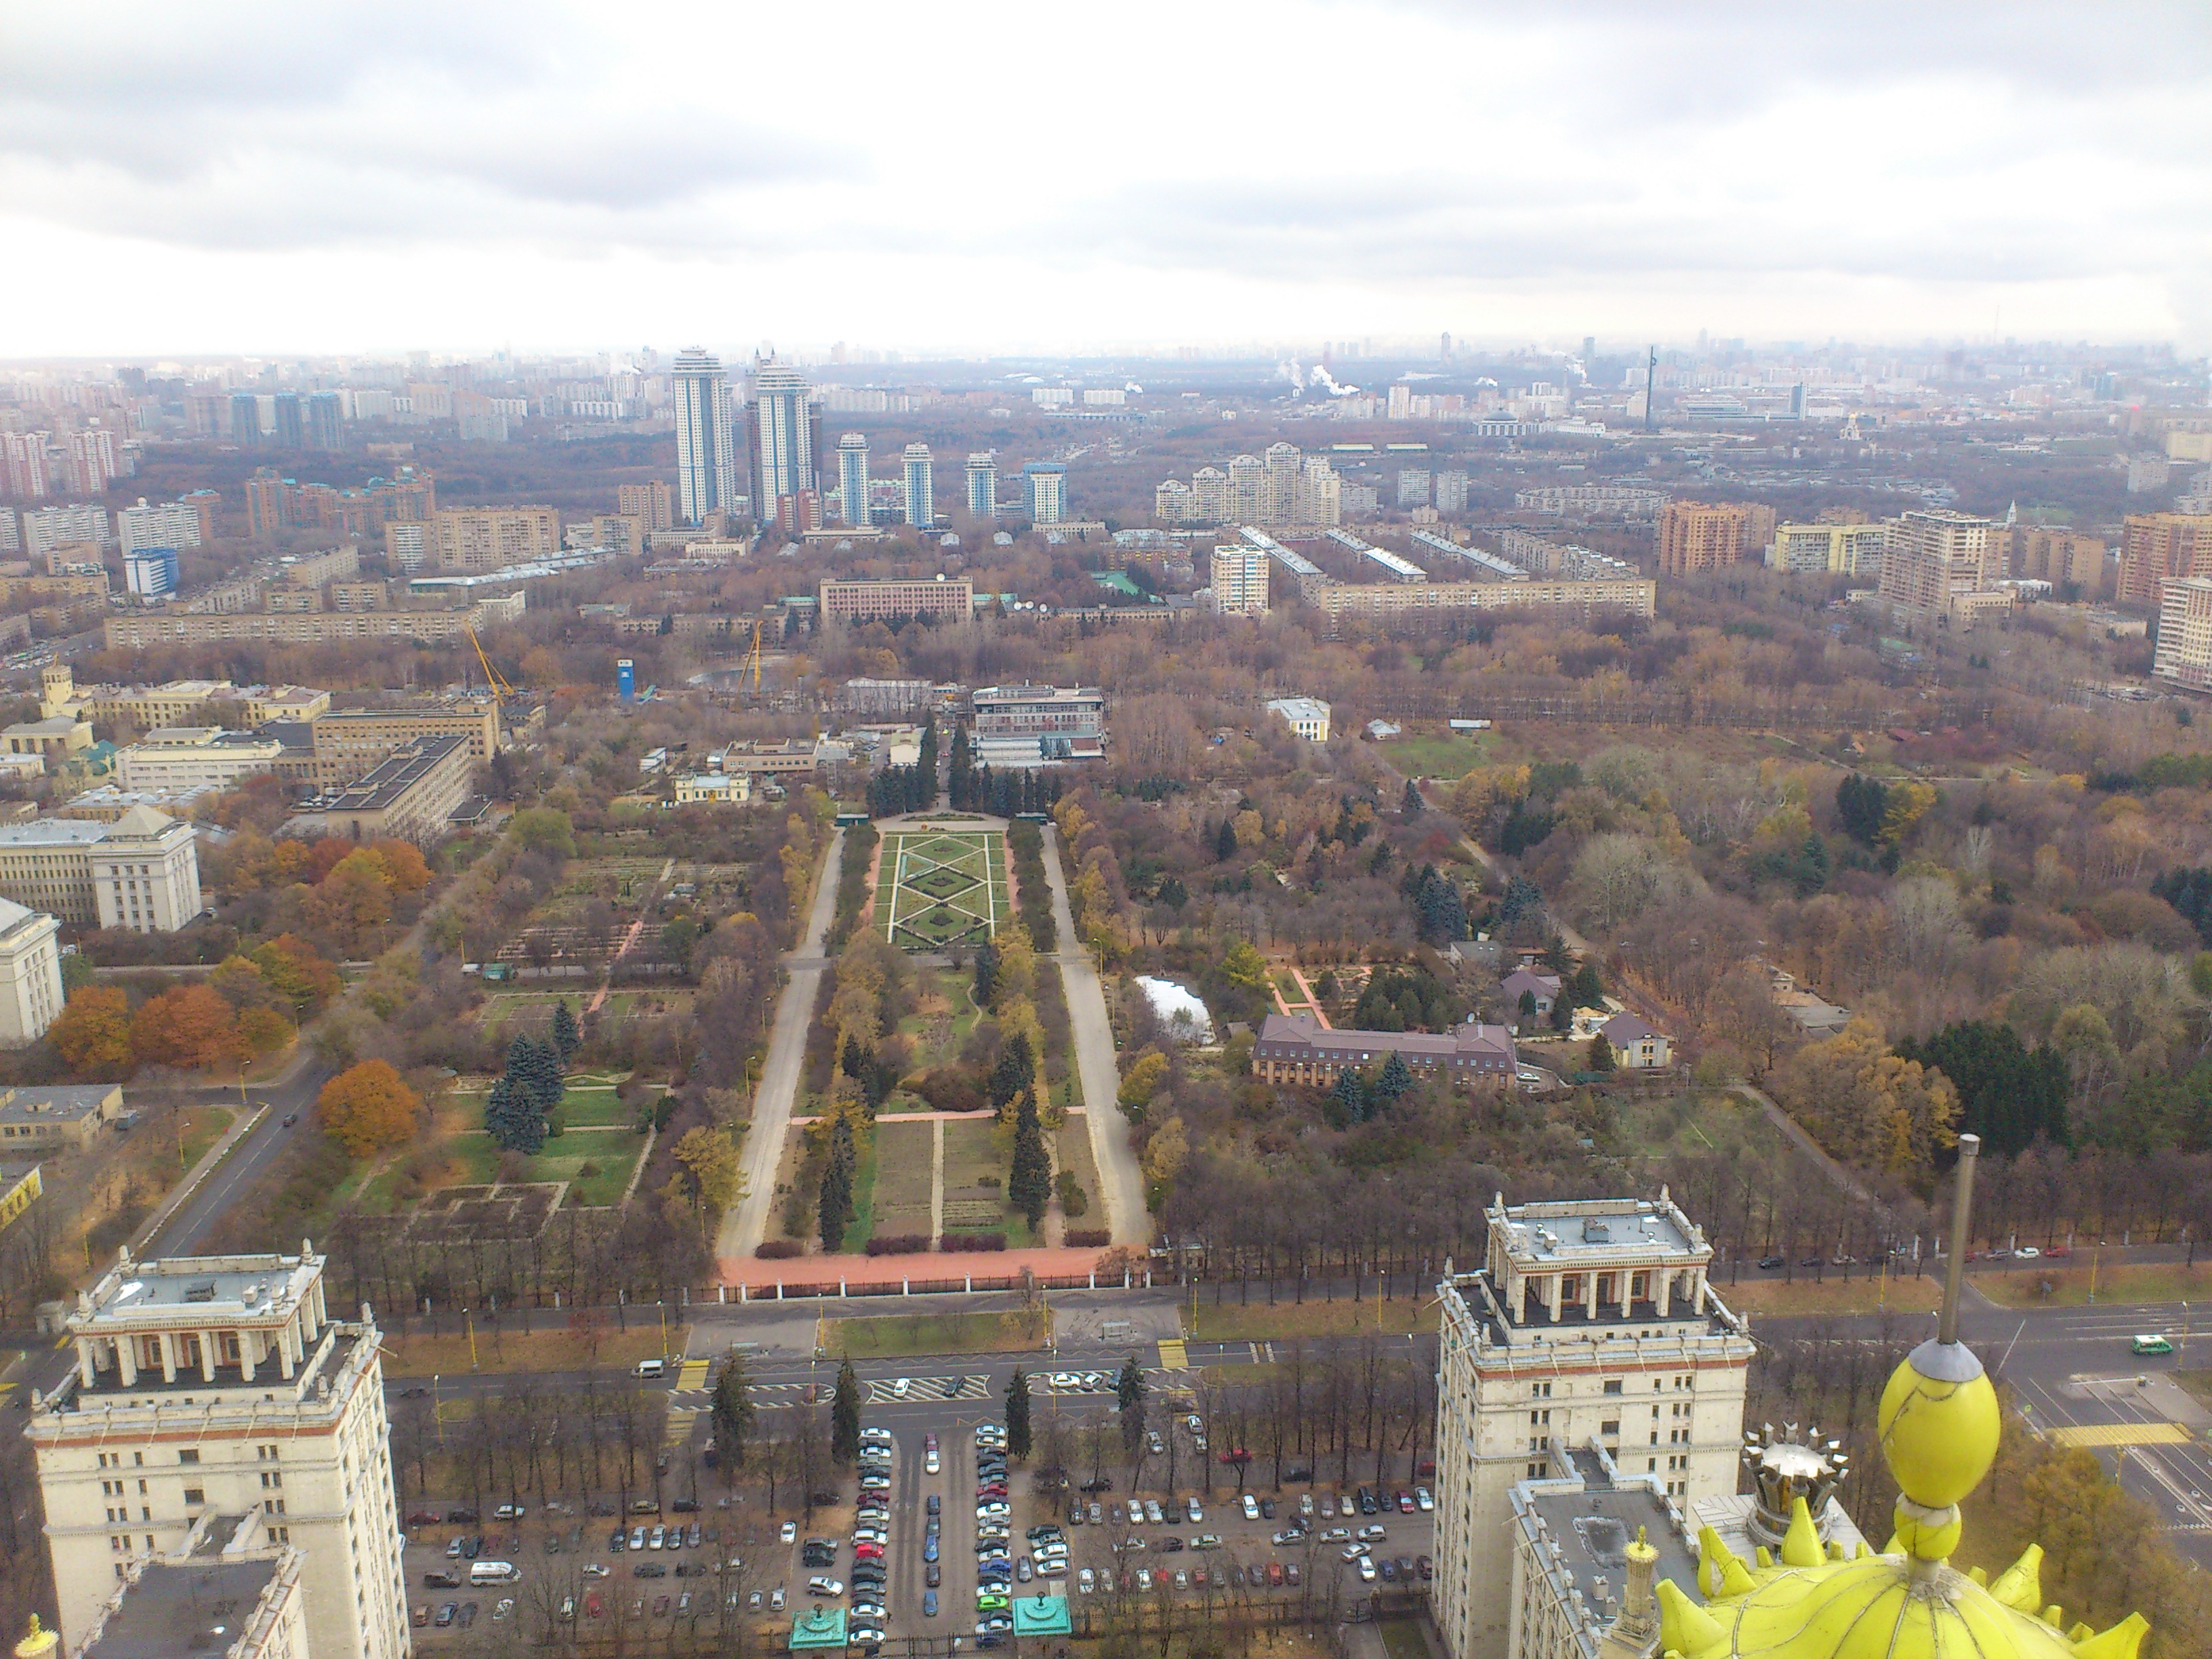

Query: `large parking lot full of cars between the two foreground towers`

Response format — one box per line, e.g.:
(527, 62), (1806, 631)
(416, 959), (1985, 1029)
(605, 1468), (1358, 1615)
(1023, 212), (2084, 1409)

(405, 1374), (1433, 1652)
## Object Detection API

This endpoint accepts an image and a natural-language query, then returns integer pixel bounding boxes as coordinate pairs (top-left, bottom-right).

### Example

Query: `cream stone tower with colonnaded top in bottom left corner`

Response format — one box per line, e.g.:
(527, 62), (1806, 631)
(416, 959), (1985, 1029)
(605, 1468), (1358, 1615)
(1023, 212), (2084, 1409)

(24, 1248), (409, 1659)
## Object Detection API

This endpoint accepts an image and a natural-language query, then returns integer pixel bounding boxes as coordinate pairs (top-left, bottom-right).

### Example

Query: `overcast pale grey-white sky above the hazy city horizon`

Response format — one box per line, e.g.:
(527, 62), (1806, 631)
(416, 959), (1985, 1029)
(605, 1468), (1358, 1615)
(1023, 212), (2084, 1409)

(0, 0), (2212, 359)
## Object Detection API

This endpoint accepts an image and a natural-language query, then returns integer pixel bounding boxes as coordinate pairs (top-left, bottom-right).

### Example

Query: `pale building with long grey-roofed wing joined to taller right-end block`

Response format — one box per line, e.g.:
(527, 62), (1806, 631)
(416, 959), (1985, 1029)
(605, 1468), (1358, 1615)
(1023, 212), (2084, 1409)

(0, 807), (201, 933)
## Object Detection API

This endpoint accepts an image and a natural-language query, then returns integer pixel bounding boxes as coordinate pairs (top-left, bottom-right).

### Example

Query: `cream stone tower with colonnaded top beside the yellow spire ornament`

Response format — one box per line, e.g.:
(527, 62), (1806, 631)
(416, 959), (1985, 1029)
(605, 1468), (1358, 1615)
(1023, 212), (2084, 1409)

(1431, 1188), (1754, 1659)
